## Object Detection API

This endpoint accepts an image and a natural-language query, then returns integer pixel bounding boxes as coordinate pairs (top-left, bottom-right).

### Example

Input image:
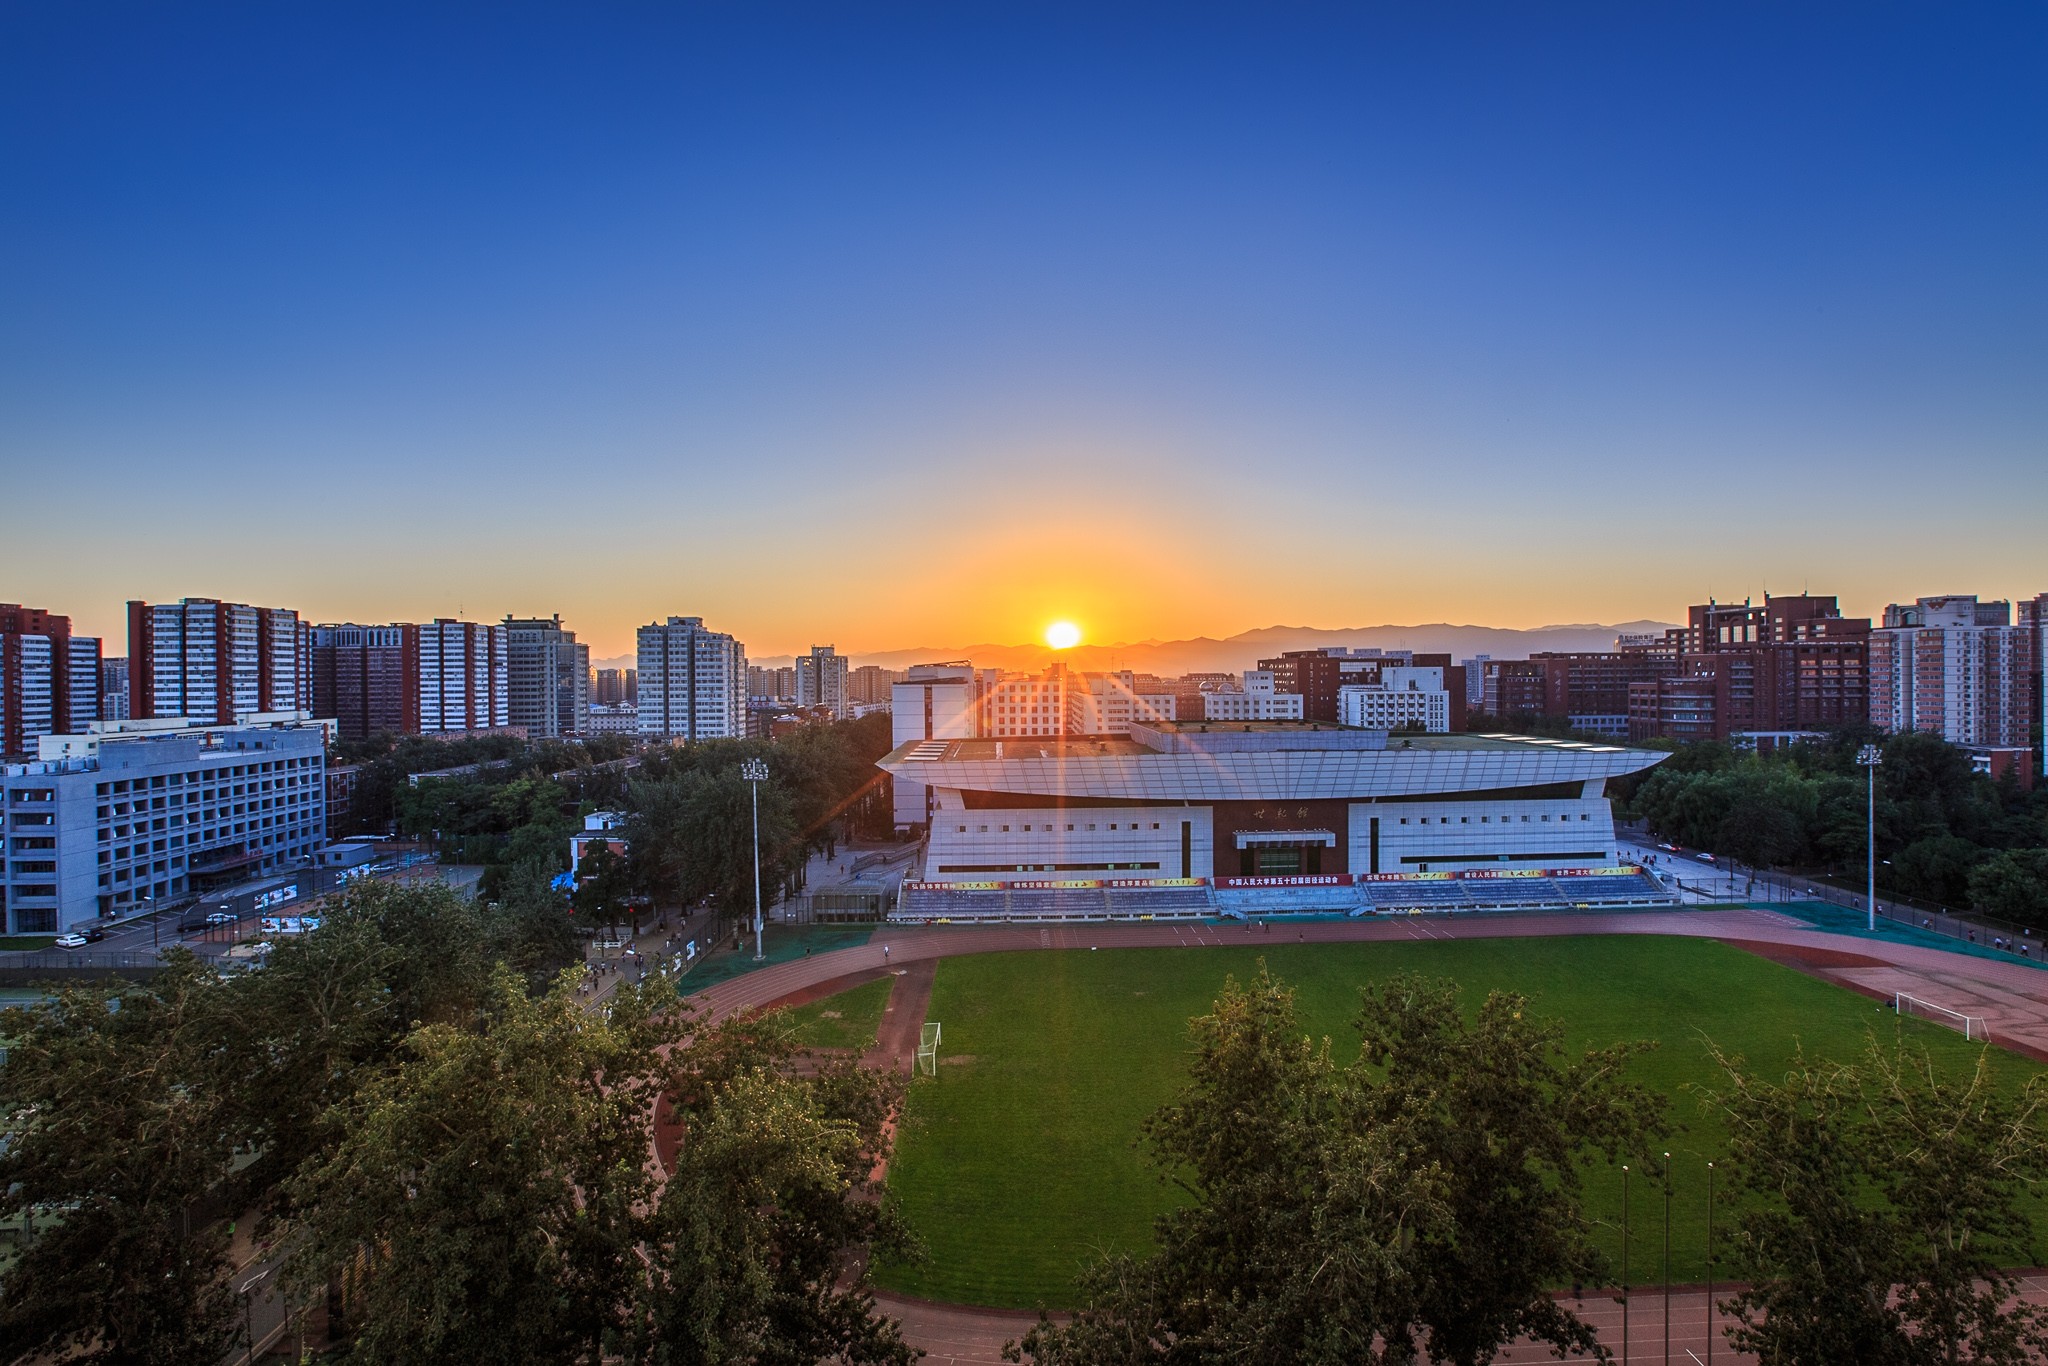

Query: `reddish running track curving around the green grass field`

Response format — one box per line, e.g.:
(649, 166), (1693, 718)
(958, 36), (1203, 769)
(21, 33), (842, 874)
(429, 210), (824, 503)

(690, 909), (2048, 1366)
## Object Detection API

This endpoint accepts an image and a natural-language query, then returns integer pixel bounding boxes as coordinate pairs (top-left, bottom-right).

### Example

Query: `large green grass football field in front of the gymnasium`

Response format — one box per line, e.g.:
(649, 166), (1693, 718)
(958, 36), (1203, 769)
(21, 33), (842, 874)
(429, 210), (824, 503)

(877, 936), (2044, 1309)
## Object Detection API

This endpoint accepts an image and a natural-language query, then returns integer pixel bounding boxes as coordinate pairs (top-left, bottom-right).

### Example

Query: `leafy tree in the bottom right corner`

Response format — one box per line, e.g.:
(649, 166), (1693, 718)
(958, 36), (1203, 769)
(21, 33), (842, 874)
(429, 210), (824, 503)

(1710, 1038), (2048, 1366)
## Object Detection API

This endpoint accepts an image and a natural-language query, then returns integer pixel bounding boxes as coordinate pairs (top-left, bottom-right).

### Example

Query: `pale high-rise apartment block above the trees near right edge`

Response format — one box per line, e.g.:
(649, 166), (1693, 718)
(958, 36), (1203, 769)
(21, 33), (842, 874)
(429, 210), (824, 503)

(1870, 594), (2040, 750)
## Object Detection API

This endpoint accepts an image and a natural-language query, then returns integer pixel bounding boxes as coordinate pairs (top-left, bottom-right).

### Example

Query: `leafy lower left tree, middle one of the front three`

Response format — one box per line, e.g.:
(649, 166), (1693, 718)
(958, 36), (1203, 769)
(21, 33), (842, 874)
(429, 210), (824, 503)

(291, 969), (666, 1366)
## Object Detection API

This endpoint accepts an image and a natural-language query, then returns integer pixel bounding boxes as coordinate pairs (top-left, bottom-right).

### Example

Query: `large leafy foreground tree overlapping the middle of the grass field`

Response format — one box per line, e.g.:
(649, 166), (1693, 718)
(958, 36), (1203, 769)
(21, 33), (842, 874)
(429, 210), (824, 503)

(1018, 967), (1661, 1366)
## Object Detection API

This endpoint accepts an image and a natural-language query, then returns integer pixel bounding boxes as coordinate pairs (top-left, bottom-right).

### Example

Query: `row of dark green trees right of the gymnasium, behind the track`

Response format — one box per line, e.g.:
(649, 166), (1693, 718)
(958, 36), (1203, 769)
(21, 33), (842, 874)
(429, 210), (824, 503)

(1616, 727), (2048, 928)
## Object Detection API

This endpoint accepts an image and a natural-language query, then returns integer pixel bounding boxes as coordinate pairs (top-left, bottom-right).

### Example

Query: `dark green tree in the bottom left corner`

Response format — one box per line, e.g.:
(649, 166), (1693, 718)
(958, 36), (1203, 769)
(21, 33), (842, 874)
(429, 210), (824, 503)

(0, 952), (236, 1366)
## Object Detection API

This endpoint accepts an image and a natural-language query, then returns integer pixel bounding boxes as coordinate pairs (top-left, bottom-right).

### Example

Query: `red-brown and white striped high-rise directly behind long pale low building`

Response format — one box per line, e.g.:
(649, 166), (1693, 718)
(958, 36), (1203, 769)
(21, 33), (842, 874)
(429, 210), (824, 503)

(129, 598), (313, 725)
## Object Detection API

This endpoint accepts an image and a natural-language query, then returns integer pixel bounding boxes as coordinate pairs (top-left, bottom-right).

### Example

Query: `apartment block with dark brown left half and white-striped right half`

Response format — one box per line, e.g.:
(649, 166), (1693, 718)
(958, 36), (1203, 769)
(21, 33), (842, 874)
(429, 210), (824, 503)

(311, 618), (510, 739)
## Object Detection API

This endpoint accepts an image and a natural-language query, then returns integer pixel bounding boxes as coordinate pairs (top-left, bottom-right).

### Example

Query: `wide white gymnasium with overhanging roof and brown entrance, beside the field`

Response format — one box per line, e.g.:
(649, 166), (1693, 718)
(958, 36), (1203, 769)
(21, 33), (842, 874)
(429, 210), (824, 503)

(881, 719), (1673, 920)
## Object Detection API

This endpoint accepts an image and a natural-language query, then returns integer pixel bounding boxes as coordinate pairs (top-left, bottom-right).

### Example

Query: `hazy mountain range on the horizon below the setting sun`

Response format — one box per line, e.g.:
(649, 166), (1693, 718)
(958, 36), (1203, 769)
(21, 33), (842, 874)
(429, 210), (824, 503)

(592, 621), (1671, 678)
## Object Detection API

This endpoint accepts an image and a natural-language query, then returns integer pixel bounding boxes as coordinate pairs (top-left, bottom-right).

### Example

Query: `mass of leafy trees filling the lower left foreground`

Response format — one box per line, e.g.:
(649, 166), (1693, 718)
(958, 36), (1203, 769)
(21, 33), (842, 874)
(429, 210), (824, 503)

(0, 885), (913, 1364)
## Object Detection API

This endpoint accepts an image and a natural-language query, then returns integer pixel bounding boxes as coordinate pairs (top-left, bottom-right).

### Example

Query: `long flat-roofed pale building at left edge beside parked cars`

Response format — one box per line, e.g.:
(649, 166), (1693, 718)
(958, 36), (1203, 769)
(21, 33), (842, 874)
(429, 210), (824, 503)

(0, 713), (328, 934)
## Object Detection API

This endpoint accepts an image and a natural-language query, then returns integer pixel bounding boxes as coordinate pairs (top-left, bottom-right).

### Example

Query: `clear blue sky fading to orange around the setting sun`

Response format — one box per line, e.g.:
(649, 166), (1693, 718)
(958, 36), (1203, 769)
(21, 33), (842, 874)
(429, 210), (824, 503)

(0, 2), (2048, 657)
